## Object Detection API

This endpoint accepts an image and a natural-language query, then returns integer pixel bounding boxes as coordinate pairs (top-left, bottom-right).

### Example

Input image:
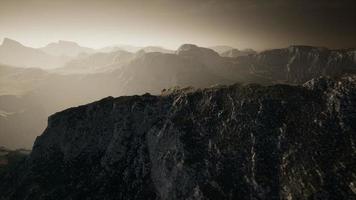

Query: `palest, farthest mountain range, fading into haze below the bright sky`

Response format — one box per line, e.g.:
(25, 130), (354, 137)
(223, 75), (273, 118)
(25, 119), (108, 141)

(0, 38), (174, 70)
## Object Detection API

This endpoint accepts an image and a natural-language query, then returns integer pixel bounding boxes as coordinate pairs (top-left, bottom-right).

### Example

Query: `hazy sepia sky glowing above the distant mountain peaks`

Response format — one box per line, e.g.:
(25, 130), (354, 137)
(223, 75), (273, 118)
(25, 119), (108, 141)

(0, 0), (356, 49)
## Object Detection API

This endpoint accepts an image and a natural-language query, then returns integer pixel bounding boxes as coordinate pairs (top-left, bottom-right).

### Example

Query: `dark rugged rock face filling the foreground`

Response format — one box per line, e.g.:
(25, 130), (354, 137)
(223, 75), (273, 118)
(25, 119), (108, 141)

(0, 77), (356, 199)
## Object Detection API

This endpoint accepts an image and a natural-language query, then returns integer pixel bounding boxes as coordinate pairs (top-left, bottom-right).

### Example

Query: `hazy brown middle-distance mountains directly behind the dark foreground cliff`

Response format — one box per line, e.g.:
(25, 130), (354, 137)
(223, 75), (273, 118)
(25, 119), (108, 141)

(0, 40), (356, 148)
